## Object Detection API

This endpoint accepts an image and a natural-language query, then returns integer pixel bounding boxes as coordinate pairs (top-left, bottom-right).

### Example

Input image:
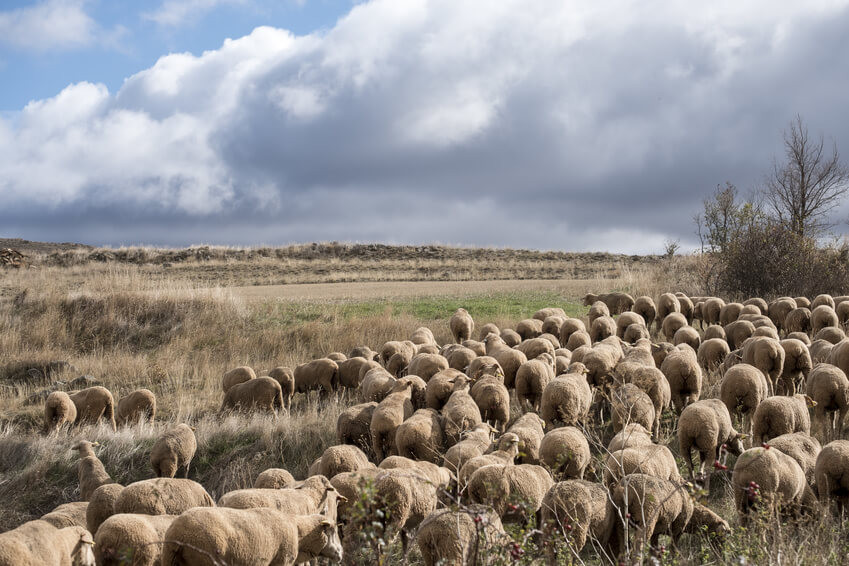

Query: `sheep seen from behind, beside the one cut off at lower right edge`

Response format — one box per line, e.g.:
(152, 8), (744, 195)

(731, 445), (822, 524)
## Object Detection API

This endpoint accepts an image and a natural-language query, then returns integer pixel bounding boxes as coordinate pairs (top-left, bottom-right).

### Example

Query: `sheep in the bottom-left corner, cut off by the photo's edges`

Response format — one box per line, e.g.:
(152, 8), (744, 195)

(0, 520), (94, 566)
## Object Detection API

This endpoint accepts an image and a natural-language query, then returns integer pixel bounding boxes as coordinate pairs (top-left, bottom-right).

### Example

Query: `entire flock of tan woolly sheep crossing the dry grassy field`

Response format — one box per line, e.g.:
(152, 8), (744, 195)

(0, 293), (849, 566)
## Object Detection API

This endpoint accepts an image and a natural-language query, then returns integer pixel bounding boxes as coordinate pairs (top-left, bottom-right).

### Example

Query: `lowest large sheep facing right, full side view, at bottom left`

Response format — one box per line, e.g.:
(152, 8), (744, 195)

(162, 509), (342, 566)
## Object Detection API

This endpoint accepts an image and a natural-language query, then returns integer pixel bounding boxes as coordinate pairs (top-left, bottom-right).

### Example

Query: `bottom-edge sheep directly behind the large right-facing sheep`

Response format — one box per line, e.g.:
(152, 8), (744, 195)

(94, 513), (176, 566)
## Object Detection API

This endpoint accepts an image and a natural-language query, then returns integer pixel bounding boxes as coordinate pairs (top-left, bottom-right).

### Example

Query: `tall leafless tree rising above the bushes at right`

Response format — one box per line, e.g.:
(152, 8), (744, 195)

(764, 115), (849, 237)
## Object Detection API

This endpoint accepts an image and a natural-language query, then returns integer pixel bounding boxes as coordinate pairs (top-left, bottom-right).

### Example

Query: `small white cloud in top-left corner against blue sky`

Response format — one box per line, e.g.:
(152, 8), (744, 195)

(0, 0), (98, 51)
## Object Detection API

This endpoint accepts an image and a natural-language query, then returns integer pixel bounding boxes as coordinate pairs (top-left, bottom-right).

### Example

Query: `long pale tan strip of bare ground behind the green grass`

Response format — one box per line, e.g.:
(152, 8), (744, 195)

(227, 279), (593, 301)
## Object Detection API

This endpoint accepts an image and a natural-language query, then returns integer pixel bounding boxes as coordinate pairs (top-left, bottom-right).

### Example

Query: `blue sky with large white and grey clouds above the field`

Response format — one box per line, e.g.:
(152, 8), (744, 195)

(0, 0), (849, 253)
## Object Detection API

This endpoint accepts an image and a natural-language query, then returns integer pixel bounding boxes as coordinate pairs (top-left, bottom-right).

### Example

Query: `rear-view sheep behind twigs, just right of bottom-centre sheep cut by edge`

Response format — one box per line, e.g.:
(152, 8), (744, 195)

(540, 482), (612, 564)
